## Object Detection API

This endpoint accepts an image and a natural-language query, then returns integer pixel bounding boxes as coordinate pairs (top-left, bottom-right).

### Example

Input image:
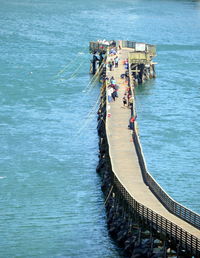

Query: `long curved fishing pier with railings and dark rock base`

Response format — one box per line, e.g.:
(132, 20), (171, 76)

(90, 41), (200, 257)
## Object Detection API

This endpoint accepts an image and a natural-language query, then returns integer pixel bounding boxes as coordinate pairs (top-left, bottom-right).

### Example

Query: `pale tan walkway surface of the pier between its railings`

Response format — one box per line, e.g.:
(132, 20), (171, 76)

(106, 48), (200, 238)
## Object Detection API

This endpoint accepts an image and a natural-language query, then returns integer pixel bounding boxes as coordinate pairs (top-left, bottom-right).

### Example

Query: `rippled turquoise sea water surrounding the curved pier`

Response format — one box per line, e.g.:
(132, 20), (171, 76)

(0, 0), (200, 258)
